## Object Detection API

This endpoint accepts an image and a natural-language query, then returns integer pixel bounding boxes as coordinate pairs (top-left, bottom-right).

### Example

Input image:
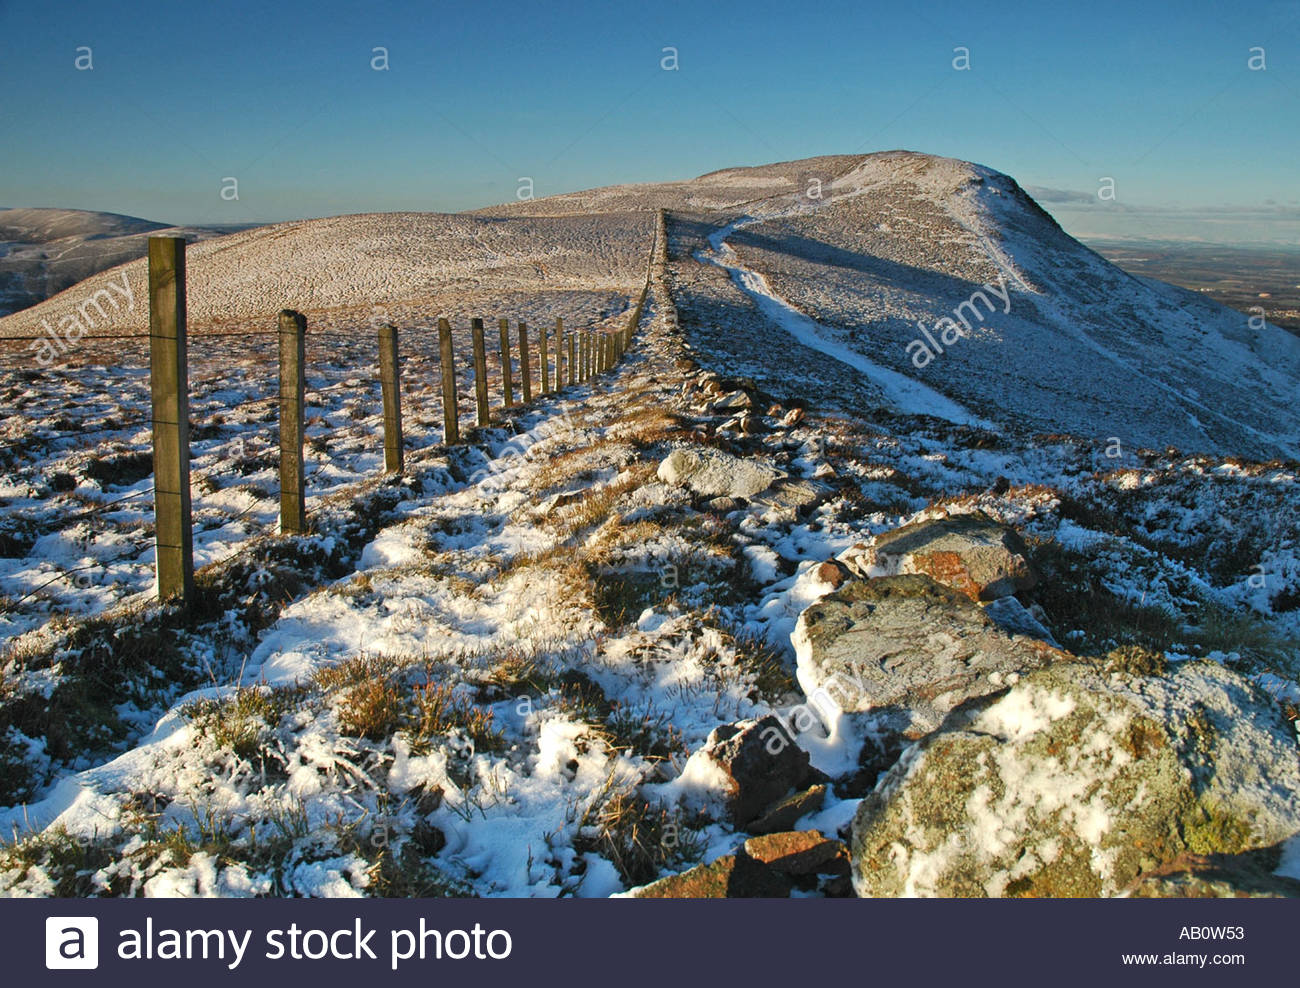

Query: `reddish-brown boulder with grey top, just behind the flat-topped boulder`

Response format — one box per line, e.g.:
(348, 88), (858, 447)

(846, 511), (1037, 601)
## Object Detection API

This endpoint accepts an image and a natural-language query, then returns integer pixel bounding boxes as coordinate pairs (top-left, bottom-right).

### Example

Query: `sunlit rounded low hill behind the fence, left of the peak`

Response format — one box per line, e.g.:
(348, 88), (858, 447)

(0, 213), (654, 337)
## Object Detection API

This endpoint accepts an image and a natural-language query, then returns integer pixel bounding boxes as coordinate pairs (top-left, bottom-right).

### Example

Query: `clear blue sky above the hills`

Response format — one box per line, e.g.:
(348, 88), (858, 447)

(0, 0), (1300, 242)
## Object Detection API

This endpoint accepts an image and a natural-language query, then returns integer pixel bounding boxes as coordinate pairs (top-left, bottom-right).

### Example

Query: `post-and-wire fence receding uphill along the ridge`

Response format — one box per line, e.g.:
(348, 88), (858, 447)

(0, 212), (663, 615)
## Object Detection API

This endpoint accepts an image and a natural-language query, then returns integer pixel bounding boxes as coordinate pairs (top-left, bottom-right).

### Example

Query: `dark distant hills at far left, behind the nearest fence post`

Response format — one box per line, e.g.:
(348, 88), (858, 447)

(0, 209), (248, 316)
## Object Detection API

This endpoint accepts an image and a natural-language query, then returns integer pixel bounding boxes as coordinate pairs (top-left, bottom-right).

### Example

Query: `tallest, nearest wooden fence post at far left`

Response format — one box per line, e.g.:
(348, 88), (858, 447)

(150, 237), (194, 607)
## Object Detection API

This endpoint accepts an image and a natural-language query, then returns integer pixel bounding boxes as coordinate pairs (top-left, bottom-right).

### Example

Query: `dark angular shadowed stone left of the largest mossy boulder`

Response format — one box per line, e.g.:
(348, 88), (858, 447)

(703, 714), (810, 828)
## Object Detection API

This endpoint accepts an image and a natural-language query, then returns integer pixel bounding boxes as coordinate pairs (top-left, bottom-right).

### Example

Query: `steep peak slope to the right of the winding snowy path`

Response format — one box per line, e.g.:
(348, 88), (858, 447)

(733, 153), (1300, 456)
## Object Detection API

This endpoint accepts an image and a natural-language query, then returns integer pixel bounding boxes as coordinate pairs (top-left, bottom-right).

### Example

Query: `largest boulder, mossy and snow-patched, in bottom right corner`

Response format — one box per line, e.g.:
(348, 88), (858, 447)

(852, 662), (1300, 897)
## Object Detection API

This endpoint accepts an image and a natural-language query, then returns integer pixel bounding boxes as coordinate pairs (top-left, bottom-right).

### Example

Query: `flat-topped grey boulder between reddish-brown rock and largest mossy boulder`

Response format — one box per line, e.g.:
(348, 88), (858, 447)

(793, 575), (1071, 732)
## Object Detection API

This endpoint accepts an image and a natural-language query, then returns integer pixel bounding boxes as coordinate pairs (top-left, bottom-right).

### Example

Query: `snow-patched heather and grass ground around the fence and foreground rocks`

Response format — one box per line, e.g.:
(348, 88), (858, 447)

(0, 152), (1300, 896)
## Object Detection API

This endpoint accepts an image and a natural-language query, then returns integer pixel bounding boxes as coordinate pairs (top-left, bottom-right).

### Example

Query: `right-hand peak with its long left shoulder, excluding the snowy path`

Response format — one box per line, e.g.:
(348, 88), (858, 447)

(493, 151), (1300, 458)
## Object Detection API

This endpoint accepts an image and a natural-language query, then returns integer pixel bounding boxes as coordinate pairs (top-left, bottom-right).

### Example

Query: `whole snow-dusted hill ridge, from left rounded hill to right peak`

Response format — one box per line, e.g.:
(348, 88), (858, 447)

(0, 151), (1300, 459)
